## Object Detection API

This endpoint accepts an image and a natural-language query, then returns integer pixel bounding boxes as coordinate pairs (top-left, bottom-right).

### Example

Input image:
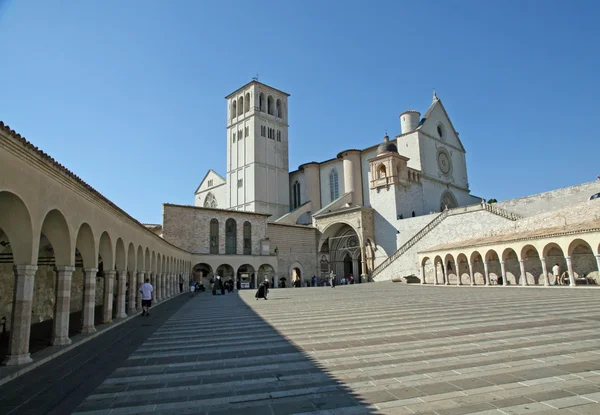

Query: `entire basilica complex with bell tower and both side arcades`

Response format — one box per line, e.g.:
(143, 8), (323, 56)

(0, 80), (600, 366)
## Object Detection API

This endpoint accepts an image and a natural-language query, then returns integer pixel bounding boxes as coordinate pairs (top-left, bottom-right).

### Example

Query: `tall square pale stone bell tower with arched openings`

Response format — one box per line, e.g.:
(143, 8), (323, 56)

(225, 81), (289, 220)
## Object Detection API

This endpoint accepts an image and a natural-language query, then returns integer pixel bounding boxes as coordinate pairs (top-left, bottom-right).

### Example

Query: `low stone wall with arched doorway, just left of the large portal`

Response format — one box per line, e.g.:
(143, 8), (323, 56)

(267, 223), (319, 286)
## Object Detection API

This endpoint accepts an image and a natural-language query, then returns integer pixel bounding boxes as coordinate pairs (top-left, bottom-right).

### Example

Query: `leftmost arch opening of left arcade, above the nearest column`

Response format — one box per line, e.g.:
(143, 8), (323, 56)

(0, 191), (37, 265)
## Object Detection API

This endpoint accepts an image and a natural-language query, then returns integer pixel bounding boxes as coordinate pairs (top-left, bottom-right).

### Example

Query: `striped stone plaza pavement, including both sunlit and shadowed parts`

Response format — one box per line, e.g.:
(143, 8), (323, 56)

(71, 283), (600, 415)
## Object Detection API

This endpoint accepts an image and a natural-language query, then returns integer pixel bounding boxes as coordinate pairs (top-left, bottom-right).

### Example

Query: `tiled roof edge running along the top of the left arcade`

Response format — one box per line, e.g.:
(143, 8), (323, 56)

(0, 121), (193, 255)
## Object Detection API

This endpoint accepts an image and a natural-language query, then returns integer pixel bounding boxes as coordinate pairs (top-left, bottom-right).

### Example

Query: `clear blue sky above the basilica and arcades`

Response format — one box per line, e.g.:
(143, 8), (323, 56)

(0, 0), (600, 223)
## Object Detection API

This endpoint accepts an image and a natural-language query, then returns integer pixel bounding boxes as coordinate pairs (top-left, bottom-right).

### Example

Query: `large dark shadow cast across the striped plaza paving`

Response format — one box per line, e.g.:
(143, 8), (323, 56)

(75, 291), (376, 415)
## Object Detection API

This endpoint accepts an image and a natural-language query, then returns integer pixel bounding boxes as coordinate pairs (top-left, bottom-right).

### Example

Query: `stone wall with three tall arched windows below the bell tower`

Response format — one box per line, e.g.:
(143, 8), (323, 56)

(163, 204), (267, 255)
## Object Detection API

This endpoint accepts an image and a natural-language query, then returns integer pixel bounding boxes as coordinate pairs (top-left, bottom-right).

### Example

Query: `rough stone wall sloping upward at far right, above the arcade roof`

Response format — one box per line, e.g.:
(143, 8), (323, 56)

(496, 180), (600, 216)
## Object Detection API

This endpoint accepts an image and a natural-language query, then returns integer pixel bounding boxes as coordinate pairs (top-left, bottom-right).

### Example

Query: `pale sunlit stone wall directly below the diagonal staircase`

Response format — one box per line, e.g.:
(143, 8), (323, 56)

(376, 210), (509, 281)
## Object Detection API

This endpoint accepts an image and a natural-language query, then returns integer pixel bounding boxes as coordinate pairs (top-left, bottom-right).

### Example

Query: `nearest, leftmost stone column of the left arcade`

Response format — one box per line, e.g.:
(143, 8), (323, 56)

(3, 265), (37, 366)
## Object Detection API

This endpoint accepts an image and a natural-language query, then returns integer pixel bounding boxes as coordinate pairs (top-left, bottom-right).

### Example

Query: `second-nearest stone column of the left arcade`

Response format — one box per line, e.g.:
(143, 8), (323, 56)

(52, 266), (75, 346)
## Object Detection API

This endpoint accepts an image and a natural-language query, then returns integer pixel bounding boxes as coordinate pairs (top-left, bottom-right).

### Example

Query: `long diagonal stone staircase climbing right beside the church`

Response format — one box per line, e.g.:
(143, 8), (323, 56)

(371, 203), (523, 279)
